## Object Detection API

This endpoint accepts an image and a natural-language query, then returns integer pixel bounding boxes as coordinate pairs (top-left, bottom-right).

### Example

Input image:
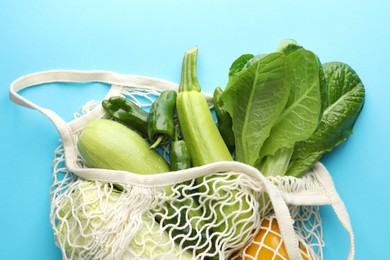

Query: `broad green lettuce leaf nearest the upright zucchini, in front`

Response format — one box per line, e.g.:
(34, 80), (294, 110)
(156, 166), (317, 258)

(222, 52), (293, 166)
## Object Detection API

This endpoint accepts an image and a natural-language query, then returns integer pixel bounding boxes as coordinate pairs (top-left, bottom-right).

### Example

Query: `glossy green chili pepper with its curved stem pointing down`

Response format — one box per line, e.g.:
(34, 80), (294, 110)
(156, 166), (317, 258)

(148, 90), (176, 149)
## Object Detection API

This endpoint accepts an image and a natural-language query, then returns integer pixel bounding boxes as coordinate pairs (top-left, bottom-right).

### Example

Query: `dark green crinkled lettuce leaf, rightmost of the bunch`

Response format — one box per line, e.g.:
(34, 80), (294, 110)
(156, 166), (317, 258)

(287, 62), (365, 177)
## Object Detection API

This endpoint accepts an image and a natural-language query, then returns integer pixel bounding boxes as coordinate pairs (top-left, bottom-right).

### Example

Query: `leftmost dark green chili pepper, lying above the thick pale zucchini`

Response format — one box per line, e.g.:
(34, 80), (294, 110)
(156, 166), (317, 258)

(102, 96), (149, 134)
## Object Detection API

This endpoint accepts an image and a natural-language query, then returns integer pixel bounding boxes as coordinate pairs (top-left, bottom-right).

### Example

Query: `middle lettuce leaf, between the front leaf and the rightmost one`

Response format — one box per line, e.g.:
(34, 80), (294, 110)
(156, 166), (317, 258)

(257, 48), (321, 176)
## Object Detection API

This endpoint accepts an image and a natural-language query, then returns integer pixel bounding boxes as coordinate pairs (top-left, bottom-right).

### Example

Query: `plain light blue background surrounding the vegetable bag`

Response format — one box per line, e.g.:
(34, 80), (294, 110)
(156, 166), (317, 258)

(0, 0), (390, 260)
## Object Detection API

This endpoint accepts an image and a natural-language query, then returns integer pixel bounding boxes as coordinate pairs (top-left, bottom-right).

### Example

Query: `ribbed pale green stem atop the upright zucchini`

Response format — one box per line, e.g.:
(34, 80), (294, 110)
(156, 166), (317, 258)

(179, 47), (201, 92)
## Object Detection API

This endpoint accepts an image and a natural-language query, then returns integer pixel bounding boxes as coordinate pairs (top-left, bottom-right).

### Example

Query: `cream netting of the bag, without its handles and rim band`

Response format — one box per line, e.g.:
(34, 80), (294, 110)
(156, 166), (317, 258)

(51, 87), (323, 259)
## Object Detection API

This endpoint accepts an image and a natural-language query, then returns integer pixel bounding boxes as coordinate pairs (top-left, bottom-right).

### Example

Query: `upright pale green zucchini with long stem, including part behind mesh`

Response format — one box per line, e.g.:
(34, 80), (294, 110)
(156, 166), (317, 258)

(177, 48), (253, 246)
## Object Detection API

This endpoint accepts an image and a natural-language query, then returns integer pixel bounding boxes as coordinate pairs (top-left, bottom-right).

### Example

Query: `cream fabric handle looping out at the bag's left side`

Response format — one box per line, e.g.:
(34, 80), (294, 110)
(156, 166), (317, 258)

(9, 70), (177, 173)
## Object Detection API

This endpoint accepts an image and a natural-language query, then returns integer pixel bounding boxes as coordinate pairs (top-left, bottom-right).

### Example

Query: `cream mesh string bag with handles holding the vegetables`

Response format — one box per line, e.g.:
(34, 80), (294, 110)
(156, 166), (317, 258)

(10, 71), (354, 259)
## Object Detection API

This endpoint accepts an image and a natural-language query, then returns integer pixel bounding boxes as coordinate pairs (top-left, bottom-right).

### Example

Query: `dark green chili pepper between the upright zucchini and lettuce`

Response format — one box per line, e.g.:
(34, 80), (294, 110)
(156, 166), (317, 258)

(213, 87), (234, 148)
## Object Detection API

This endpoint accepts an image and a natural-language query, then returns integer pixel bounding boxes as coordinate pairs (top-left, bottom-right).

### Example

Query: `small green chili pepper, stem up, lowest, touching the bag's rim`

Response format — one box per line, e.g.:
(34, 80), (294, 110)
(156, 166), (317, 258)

(169, 127), (191, 171)
